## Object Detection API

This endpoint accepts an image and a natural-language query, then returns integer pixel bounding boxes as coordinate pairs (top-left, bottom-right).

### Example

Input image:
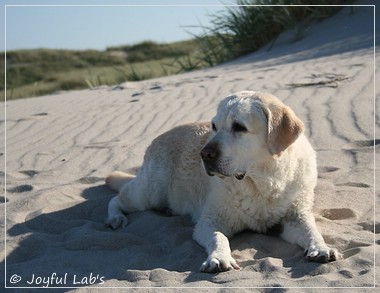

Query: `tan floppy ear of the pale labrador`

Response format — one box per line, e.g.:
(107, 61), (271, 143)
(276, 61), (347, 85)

(264, 104), (304, 156)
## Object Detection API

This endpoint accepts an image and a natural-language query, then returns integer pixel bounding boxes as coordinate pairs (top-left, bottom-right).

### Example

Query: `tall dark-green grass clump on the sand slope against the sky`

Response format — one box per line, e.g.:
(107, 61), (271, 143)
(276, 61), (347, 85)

(189, 0), (352, 65)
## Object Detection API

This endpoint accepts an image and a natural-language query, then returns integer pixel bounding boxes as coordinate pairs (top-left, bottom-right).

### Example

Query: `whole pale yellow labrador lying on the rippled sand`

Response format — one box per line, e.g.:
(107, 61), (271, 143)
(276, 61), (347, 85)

(106, 91), (342, 273)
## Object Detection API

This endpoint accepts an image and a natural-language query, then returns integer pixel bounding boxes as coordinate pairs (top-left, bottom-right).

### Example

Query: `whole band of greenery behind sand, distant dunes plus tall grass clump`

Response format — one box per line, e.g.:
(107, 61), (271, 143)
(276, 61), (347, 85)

(0, 0), (351, 100)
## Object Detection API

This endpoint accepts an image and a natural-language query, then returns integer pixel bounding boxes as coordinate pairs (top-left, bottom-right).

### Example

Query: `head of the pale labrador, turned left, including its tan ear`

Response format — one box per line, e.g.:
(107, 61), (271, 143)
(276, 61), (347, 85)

(201, 91), (304, 180)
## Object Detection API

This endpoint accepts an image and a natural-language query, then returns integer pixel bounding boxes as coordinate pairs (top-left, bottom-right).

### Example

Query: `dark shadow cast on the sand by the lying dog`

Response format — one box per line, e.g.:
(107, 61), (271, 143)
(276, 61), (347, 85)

(7, 185), (318, 286)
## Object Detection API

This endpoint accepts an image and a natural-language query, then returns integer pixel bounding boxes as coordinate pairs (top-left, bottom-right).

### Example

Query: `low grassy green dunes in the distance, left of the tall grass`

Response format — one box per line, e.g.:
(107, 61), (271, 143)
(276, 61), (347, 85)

(0, 41), (200, 100)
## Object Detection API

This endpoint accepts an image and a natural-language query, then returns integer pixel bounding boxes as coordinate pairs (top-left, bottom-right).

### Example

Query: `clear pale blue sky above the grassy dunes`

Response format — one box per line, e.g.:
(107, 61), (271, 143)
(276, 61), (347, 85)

(0, 0), (232, 51)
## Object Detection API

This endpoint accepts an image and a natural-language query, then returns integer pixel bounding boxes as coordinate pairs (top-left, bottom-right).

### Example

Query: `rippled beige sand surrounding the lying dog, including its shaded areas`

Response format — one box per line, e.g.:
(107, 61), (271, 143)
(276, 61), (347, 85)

(0, 3), (380, 292)
